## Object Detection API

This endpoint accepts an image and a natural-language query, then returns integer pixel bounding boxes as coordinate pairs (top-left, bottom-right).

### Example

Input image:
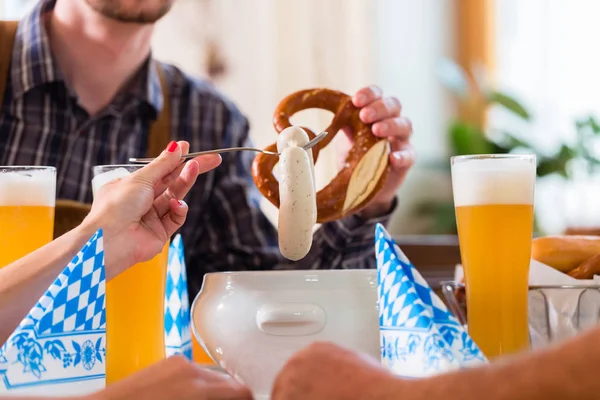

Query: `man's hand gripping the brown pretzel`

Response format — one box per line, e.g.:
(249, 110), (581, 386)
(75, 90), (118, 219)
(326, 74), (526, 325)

(345, 86), (415, 218)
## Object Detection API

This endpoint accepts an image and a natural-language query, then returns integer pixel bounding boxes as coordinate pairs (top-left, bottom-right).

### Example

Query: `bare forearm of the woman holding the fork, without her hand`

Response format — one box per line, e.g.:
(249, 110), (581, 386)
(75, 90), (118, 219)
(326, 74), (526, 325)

(0, 221), (97, 343)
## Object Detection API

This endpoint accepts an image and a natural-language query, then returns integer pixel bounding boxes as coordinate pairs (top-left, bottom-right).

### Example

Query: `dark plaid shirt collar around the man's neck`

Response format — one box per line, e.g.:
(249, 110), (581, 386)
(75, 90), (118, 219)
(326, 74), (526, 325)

(11, 0), (163, 112)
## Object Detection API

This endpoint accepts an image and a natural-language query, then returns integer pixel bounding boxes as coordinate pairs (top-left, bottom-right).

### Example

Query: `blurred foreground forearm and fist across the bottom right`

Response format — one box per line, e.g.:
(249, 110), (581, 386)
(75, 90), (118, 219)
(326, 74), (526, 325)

(271, 327), (600, 400)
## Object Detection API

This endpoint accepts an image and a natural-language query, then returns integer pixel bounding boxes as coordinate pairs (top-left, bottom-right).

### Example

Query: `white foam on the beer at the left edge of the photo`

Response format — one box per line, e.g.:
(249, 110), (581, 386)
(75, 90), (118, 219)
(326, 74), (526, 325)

(0, 170), (56, 207)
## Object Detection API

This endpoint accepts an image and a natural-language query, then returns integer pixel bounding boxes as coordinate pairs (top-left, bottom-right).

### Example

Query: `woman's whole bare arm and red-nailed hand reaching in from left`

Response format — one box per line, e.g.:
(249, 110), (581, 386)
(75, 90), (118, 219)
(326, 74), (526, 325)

(0, 142), (220, 343)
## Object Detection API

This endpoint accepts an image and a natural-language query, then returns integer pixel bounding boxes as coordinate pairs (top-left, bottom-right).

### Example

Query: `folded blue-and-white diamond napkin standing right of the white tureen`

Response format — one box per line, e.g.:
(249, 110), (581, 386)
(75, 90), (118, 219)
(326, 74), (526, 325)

(375, 224), (487, 378)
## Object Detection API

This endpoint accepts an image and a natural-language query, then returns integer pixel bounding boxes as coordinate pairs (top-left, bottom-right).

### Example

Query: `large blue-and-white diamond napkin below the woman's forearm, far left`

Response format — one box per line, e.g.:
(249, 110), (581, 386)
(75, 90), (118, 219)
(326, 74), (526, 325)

(0, 231), (106, 396)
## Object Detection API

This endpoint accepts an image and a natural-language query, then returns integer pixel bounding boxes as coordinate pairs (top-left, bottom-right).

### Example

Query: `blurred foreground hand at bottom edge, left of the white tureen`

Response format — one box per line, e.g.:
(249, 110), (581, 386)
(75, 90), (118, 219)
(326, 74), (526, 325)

(91, 356), (252, 400)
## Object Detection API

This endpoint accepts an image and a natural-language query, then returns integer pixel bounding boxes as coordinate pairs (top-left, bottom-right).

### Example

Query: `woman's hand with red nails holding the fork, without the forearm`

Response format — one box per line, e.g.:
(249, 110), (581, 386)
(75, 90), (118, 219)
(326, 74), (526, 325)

(83, 141), (221, 279)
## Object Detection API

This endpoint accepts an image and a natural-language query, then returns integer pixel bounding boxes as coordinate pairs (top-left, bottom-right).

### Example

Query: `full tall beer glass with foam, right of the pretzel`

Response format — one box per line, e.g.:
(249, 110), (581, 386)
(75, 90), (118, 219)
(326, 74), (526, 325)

(451, 155), (536, 358)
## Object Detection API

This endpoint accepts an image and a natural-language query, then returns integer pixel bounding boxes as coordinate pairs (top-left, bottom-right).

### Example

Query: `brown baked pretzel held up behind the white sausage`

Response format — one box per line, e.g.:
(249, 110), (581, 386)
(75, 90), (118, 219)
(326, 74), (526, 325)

(252, 89), (389, 223)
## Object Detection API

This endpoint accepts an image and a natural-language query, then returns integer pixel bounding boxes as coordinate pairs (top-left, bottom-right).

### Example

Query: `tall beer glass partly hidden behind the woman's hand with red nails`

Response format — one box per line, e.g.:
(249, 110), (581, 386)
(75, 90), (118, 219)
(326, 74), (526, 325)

(93, 165), (169, 385)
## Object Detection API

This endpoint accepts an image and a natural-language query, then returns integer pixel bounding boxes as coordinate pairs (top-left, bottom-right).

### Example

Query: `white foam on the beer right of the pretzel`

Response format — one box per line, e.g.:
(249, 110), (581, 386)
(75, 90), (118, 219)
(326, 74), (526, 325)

(452, 158), (536, 207)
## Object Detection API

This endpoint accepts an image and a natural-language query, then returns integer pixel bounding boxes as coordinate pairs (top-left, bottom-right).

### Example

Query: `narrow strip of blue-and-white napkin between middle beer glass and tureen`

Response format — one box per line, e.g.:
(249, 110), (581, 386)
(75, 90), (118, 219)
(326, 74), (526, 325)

(165, 235), (192, 360)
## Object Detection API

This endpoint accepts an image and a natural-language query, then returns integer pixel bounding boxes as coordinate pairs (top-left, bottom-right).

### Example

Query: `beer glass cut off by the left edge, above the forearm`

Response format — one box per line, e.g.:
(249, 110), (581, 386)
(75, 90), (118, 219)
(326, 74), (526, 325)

(0, 167), (56, 268)
